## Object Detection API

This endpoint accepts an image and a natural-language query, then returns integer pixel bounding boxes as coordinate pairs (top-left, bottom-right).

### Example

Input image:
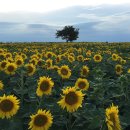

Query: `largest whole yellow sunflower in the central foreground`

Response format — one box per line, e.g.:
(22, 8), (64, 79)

(58, 87), (84, 112)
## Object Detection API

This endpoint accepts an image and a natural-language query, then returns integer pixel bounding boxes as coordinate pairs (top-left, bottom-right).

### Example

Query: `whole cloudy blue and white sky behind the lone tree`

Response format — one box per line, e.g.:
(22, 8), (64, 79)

(0, 0), (130, 42)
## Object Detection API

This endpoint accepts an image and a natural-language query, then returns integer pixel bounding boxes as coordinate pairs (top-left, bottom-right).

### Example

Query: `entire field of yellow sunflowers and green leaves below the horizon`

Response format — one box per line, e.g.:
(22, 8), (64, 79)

(0, 43), (130, 130)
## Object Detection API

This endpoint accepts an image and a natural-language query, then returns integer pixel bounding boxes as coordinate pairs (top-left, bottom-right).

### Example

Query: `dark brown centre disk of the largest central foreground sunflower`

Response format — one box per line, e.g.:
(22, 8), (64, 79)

(65, 92), (78, 105)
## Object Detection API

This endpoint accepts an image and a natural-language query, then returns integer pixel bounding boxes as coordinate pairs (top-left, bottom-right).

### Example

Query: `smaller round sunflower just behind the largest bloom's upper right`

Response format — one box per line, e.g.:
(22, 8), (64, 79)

(75, 78), (89, 90)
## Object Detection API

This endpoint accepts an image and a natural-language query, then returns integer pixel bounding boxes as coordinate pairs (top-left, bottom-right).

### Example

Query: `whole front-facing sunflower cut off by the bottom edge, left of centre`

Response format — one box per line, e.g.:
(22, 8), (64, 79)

(29, 109), (53, 130)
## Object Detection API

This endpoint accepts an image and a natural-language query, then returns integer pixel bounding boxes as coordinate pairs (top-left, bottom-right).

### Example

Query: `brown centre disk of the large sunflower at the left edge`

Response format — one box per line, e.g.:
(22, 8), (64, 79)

(0, 100), (14, 112)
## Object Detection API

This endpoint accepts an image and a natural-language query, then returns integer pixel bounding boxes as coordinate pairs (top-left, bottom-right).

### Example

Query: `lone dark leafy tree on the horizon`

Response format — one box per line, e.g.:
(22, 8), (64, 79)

(56, 26), (79, 42)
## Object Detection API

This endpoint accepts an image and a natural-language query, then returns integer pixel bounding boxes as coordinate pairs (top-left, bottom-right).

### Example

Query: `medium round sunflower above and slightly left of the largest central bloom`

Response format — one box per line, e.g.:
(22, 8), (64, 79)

(58, 65), (71, 79)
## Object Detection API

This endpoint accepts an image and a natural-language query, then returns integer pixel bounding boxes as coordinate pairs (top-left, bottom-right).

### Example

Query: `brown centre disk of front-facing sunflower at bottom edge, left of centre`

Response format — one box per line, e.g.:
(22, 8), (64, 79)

(34, 115), (48, 127)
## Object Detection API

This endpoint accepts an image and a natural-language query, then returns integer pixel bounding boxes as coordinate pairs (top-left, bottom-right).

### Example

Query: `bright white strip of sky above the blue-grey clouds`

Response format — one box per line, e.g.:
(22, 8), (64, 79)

(0, 0), (130, 13)
